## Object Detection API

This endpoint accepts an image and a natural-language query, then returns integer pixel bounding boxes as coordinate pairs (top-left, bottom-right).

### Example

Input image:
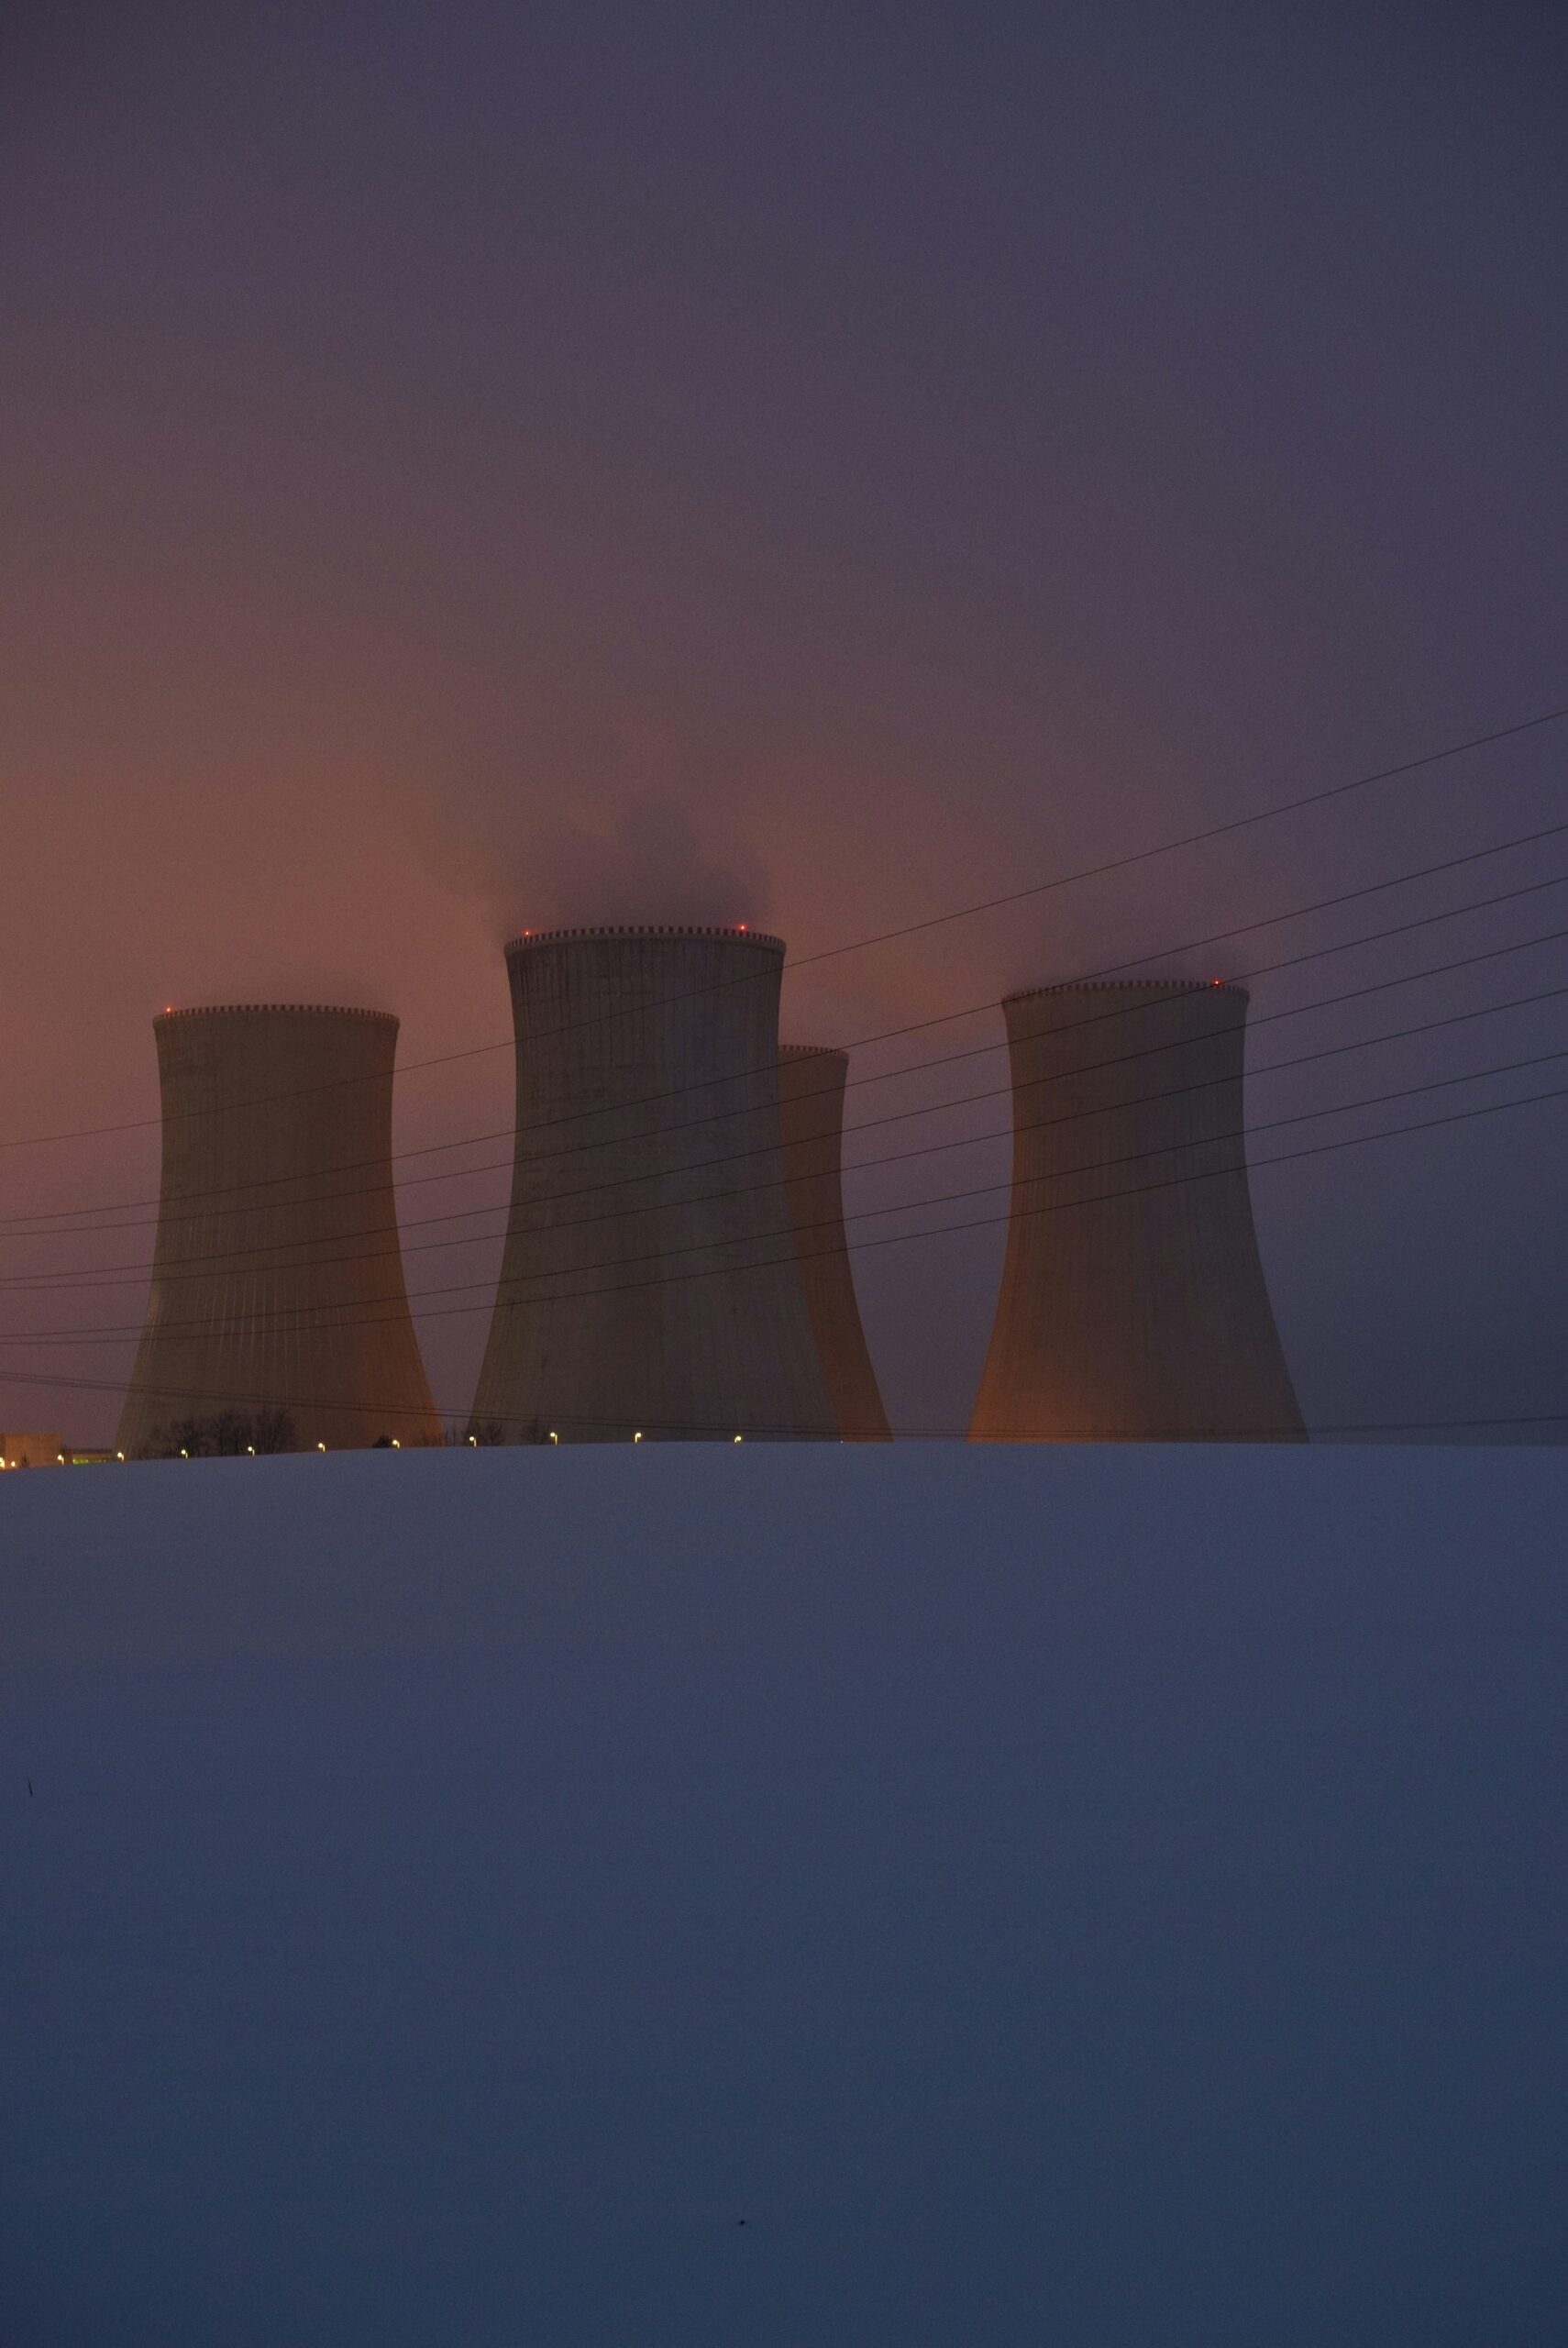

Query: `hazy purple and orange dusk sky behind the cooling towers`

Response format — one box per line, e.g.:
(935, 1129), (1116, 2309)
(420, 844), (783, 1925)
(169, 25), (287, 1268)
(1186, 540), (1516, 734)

(0, 0), (1568, 1442)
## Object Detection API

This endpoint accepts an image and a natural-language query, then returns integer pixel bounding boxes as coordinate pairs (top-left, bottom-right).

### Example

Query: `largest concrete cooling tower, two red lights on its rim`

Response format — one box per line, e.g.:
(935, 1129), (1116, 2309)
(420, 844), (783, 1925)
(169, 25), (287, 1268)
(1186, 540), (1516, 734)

(474, 927), (835, 1444)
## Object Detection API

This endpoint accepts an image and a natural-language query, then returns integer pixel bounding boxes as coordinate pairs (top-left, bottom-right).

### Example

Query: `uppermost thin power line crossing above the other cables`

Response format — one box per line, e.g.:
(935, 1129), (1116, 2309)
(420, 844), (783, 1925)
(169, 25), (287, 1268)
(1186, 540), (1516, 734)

(0, 704), (1568, 1150)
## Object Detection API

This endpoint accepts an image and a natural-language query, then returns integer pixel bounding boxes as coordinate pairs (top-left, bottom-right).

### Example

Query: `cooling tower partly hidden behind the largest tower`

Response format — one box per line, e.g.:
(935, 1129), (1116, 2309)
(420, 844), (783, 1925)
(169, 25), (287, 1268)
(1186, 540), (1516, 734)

(779, 1043), (892, 1444)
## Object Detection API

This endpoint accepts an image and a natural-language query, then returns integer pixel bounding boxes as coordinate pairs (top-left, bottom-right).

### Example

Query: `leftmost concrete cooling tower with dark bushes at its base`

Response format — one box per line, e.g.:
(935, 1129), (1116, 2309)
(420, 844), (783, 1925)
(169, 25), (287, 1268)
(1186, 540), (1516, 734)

(120, 1002), (441, 1458)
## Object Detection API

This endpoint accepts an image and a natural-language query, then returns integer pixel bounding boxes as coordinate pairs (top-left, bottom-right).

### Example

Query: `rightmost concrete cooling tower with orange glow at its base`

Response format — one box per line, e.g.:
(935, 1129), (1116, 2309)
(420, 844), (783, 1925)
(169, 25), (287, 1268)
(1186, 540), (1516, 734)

(969, 980), (1305, 1442)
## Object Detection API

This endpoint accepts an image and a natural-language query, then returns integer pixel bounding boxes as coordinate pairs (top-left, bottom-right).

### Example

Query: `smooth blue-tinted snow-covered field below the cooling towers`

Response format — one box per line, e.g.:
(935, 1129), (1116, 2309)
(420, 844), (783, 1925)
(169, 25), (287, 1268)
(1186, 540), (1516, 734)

(0, 1446), (1568, 2348)
